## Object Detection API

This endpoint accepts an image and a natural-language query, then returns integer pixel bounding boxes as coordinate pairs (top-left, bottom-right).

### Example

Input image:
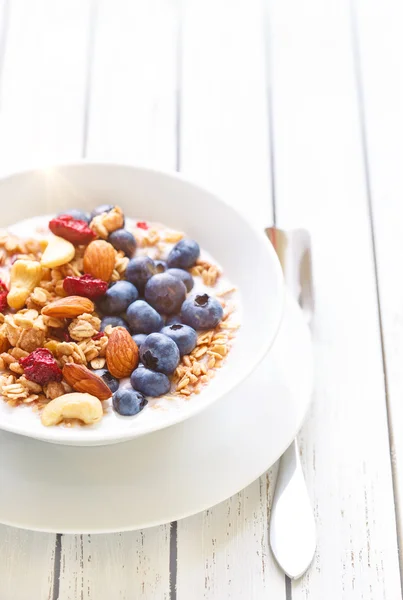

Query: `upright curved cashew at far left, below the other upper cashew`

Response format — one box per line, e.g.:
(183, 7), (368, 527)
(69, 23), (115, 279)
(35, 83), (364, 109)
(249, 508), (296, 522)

(7, 260), (42, 310)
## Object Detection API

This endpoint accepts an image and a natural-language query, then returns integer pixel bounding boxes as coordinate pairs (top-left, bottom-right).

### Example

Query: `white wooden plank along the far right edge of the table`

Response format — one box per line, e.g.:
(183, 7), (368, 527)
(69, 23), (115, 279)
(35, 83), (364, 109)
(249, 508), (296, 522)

(355, 0), (403, 571)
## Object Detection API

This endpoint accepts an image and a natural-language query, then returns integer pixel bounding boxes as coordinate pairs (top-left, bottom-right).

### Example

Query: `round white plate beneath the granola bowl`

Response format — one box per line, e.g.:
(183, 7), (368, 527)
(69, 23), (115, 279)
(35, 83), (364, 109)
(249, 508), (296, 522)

(0, 298), (313, 533)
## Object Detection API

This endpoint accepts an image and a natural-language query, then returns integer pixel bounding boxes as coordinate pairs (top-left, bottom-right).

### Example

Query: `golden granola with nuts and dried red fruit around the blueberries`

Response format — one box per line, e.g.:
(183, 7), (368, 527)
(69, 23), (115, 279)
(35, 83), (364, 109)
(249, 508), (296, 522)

(0, 206), (239, 427)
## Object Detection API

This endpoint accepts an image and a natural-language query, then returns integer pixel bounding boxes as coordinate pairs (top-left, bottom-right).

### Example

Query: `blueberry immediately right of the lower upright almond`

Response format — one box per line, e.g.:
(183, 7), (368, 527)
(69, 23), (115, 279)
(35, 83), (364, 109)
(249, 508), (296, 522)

(140, 333), (180, 375)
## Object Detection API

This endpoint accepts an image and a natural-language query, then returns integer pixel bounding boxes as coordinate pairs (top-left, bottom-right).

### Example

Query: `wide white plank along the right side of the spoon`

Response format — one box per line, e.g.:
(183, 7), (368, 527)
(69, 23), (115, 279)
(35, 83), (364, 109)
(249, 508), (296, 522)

(270, 0), (401, 600)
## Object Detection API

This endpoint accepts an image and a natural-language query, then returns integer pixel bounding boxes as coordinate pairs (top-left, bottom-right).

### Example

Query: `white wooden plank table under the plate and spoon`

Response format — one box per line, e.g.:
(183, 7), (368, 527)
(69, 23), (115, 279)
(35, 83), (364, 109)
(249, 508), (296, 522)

(0, 0), (403, 600)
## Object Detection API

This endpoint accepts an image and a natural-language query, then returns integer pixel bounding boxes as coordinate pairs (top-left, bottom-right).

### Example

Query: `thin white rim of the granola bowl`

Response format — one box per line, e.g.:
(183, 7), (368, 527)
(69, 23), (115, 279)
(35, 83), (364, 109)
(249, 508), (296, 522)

(0, 158), (286, 447)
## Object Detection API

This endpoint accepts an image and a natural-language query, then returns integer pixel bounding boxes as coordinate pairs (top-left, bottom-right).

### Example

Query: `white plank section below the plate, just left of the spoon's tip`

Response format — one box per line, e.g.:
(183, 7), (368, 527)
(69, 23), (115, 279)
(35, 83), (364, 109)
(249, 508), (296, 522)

(177, 467), (285, 600)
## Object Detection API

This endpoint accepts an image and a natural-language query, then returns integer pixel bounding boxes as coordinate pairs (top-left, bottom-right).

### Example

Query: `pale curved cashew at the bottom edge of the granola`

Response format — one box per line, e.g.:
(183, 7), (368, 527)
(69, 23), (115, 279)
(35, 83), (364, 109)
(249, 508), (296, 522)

(41, 392), (103, 427)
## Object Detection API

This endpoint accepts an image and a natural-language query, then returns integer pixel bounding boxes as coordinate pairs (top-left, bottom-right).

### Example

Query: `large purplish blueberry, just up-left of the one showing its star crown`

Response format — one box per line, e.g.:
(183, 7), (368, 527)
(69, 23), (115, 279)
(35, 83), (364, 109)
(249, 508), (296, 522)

(144, 273), (186, 315)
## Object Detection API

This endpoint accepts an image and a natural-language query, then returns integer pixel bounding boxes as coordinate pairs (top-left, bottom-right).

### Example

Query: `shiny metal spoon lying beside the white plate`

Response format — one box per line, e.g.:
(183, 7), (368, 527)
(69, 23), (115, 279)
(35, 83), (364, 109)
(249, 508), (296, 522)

(266, 227), (316, 579)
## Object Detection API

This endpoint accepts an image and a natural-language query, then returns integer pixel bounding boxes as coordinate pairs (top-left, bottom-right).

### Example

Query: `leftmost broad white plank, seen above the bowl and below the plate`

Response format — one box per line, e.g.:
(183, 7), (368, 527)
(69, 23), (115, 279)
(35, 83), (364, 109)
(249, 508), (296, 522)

(0, 0), (88, 600)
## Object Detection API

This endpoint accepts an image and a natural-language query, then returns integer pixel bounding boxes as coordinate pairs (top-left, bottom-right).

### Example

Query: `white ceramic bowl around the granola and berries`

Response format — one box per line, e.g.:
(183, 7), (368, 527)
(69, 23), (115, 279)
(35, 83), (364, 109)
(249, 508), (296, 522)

(0, 162), (285, 445)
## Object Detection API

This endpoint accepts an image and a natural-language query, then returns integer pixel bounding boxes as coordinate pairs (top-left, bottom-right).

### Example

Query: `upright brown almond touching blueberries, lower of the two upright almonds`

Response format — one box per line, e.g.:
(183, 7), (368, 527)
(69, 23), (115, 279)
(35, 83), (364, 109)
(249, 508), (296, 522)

(106, 327), (139, 379)
